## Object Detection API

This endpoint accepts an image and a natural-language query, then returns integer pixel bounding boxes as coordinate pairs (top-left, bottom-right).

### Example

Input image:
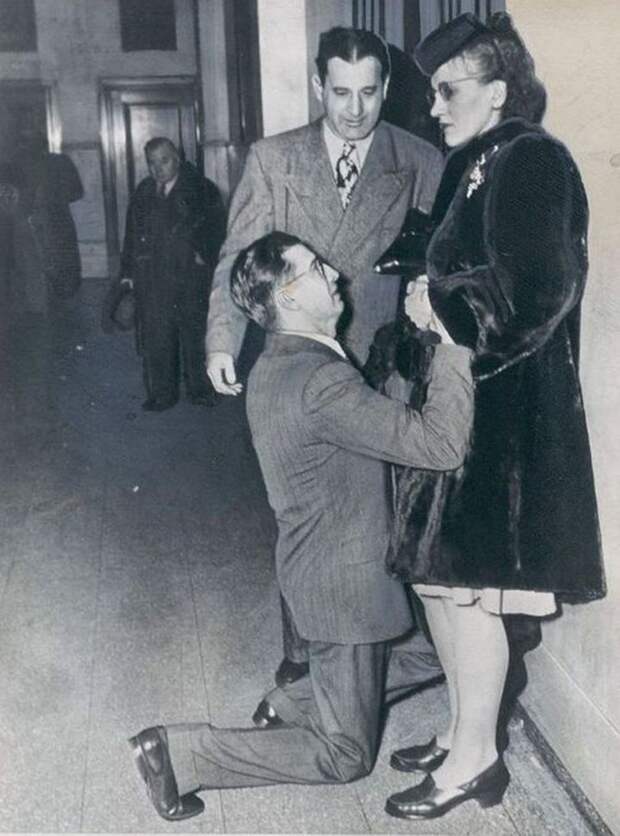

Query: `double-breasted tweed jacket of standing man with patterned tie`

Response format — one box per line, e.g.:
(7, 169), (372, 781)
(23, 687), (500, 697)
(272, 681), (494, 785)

(207, 120), (443, 362)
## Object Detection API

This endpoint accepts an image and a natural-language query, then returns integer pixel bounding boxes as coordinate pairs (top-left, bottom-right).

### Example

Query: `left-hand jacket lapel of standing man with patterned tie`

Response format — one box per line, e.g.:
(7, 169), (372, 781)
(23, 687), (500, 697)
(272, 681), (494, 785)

(285, 120), (344, 252)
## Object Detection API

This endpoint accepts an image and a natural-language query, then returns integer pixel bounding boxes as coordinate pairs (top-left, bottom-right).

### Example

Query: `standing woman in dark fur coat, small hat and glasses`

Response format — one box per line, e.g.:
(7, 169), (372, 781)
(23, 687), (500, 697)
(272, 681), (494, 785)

(375, 13), (604, 818)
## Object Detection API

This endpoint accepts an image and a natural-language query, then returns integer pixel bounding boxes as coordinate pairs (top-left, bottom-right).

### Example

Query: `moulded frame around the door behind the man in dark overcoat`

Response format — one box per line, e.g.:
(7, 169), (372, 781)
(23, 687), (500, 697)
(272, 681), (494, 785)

(99, 75), (202, 276)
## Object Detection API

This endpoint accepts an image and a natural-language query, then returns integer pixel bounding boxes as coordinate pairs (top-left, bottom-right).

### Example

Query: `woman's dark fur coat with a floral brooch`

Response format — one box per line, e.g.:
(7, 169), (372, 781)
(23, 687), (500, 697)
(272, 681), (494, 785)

(372, 119), (605, 600)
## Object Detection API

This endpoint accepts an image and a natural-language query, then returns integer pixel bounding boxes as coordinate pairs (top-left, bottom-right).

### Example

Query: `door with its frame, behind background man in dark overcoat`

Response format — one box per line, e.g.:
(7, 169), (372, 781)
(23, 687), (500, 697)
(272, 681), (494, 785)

(101, 78), (202, 275)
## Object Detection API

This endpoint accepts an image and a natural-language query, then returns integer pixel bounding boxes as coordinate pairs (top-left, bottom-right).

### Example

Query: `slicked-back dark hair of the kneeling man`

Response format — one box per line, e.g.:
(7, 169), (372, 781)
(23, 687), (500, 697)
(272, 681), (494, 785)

(230, 232), (303, 331)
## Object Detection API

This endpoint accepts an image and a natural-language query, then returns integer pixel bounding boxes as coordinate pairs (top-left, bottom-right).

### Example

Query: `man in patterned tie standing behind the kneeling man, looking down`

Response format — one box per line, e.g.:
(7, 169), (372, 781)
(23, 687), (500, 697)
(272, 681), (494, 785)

(206, 27), (443, 683)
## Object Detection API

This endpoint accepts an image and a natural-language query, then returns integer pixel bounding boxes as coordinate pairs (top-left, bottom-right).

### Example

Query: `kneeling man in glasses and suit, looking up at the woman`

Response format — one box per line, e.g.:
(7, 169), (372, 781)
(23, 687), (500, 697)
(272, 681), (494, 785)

(130, 232), (473, 820)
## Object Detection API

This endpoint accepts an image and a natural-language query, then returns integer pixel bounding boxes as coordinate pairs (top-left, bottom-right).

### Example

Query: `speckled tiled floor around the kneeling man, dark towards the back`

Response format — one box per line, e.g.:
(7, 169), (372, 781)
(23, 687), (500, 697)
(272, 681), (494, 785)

(0, 281), (591, 836)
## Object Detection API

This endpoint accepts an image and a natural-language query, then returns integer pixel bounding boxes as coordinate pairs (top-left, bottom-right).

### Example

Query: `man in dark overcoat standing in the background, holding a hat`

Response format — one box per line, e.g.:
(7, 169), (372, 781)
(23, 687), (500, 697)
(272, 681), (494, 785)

(121, 137), (226, 412)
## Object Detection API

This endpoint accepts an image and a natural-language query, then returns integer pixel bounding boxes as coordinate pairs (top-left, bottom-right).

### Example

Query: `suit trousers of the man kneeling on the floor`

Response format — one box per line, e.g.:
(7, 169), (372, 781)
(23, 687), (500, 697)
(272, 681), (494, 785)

(167, 636), (442, 795)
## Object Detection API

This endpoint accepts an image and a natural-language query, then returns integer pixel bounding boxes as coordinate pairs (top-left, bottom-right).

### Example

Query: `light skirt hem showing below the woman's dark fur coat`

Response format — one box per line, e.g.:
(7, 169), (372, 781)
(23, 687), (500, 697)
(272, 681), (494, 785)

(412, 583), (558, 617)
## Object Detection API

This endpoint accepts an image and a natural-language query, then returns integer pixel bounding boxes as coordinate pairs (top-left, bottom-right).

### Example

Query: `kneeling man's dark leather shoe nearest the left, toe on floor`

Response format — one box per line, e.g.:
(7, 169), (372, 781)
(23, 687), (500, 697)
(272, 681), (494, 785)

(129, 726), (205, 821)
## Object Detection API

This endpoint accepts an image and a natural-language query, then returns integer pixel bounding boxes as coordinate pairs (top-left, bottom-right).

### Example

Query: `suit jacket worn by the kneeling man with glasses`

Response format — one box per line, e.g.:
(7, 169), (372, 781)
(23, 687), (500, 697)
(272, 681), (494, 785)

(247, 334), (473, 644)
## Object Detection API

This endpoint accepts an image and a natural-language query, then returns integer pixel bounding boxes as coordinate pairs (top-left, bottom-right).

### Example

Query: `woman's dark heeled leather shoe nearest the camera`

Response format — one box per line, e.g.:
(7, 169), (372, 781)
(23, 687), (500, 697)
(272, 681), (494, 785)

(385, 758), (510, 819)
